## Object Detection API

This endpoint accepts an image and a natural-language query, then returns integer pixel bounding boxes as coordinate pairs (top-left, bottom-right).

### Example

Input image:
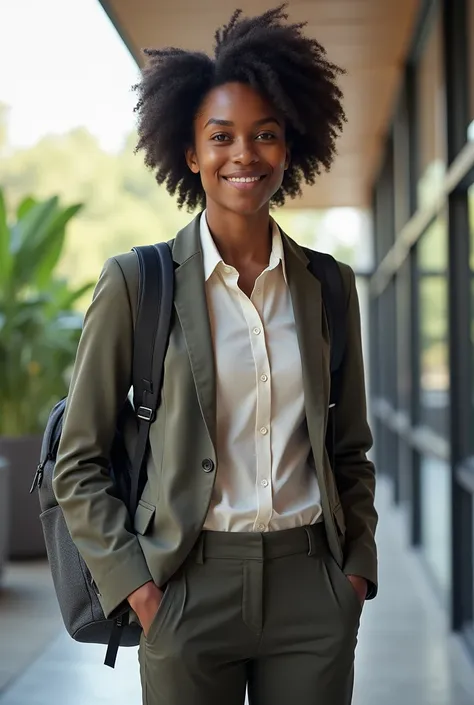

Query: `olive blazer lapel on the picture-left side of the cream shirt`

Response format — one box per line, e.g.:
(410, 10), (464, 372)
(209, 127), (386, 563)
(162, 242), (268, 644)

(173, 215), (216, 446)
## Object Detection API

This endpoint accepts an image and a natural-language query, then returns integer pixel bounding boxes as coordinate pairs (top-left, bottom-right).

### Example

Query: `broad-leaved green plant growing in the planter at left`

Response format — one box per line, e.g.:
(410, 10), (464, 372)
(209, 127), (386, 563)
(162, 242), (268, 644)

(0, 189), (92, 436)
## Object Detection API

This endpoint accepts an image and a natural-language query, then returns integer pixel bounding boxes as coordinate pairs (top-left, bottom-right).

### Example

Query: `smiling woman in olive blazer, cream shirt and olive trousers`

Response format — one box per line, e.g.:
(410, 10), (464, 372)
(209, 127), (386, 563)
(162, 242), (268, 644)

(55, 7), (377, 705)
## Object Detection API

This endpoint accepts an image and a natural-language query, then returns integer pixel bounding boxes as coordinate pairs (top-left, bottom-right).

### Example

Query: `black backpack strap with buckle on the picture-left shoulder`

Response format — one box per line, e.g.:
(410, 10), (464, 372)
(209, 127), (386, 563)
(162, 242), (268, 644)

(129, 242), (174, 515)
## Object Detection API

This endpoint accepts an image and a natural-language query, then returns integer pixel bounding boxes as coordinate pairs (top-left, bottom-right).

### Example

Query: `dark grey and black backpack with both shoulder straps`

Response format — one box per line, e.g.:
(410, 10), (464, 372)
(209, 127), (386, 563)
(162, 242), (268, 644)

(30, 243), (346, 668)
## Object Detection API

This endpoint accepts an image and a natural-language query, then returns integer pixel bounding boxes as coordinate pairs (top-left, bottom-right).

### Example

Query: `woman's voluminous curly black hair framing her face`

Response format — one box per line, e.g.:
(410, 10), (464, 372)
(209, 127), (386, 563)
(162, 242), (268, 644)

(133, 4), (346, 211)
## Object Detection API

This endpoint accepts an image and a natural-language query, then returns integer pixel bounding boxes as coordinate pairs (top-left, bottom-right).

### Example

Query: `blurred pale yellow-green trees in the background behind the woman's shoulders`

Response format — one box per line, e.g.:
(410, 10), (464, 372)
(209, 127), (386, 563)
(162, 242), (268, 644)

(0, 113), (362, 308)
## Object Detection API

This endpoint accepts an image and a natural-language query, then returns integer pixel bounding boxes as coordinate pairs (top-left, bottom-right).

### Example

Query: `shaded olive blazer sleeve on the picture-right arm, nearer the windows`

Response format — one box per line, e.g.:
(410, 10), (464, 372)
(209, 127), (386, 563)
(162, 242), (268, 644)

(335, 265), (378, 599)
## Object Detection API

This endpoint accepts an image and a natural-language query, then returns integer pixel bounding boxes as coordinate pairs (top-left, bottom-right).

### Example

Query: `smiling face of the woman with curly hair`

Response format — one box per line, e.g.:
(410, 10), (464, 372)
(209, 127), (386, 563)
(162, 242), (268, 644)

(186, 83), (289, 215)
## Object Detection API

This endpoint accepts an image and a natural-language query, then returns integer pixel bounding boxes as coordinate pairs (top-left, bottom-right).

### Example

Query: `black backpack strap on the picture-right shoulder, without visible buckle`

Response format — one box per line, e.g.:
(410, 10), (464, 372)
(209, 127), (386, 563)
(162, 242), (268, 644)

(303, 247), (346, 406)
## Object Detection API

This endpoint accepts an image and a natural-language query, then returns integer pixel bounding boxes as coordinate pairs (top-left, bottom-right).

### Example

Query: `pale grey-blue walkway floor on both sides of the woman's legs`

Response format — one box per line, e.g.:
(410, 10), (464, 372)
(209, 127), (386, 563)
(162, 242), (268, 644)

(0, 476), (474, 705)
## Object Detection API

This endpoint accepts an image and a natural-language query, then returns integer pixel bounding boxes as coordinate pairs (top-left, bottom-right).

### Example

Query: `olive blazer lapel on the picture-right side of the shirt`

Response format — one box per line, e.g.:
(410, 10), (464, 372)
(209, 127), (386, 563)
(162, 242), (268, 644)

(282, 233), (329, 474)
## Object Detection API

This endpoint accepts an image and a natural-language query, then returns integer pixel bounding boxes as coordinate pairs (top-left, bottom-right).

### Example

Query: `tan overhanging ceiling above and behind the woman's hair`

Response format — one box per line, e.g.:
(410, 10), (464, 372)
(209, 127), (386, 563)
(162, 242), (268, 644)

(101, 0), (420, 208)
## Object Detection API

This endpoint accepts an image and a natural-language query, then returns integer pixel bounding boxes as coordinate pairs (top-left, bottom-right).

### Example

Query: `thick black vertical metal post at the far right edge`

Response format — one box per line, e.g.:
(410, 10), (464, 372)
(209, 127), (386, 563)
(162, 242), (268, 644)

(443, 2), (474, 630)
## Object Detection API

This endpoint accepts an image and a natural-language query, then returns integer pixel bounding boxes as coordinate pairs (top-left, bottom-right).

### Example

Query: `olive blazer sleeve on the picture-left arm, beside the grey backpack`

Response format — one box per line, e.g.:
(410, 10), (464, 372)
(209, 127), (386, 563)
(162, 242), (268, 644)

(53, 258), (152, 617)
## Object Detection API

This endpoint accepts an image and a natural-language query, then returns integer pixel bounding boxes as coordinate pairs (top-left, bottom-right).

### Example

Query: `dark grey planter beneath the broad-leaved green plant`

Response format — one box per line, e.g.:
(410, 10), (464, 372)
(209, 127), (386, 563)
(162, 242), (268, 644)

(0, 436), (46, 559)
